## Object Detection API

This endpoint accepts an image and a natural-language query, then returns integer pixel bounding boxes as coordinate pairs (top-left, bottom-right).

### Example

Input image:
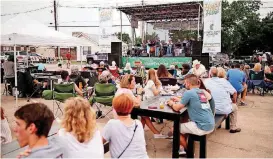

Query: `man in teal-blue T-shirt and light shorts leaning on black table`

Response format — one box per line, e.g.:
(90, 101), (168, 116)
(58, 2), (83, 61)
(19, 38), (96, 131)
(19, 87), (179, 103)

(168, 74), (215, 153)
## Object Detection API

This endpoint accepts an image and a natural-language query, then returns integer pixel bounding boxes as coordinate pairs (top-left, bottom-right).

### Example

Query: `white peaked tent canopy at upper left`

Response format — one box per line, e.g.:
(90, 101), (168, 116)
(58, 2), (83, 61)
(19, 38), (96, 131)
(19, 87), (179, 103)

(1, 15), (90, 46)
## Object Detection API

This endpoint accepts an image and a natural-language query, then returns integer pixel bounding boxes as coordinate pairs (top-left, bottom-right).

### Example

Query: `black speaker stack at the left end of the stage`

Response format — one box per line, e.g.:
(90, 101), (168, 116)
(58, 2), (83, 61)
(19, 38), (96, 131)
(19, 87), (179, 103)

(108, 42), (122, 67)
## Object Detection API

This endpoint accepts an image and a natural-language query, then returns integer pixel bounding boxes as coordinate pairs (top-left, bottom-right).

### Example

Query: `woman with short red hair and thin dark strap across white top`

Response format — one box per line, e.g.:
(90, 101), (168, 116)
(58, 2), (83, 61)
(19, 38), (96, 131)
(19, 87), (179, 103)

(102, 93), (148, 158)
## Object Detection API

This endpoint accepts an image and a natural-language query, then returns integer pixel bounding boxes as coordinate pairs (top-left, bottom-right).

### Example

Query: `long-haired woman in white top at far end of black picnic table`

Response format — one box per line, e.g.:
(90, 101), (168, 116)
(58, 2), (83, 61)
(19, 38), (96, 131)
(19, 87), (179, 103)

(144, 69), (161, 99)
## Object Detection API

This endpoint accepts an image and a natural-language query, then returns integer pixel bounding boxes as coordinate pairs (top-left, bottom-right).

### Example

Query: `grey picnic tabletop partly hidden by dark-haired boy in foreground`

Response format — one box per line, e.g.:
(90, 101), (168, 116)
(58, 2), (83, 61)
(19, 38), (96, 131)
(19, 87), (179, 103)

(1, 124), (60, 158)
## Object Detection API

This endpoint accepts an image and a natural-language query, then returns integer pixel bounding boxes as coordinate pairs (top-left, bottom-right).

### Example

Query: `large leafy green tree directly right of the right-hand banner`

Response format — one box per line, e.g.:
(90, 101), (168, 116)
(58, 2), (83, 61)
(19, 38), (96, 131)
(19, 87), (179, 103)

(221, 0), (261, 54)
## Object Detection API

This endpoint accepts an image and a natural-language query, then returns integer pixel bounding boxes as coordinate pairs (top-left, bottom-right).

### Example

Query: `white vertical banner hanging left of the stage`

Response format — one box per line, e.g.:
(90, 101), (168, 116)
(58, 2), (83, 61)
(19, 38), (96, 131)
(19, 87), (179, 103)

(99, 8), (113, 53)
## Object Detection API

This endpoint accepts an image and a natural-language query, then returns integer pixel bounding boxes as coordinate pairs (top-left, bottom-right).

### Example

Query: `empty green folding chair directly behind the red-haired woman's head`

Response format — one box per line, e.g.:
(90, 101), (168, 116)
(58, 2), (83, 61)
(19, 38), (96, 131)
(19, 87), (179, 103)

(89, 83), (116, 119)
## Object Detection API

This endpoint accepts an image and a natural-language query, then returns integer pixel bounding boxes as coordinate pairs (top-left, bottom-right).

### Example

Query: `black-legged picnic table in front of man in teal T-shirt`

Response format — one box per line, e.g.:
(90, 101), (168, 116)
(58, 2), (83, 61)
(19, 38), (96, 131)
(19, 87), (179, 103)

(131, 96), (187, 158)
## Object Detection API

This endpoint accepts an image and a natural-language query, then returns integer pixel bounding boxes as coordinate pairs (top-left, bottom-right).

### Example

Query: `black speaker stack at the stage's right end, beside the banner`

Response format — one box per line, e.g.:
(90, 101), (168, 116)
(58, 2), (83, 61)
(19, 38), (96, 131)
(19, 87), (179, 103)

(191, 41), (209, 69)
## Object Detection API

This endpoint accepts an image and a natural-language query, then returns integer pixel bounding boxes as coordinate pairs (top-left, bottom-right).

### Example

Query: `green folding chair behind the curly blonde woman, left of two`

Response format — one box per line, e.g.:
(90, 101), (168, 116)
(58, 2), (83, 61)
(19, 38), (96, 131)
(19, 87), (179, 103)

(52, 83), (76, 116)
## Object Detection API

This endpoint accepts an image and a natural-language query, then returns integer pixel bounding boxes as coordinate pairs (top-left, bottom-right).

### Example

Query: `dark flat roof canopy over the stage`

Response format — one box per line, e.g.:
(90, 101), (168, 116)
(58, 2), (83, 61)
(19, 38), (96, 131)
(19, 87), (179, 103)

(117, 2), (202, 22)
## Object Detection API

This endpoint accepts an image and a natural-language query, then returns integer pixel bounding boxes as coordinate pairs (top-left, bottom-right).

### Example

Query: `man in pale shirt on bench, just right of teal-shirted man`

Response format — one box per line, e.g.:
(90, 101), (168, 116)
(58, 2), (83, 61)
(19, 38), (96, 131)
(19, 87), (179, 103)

(204, 67), (241, 133)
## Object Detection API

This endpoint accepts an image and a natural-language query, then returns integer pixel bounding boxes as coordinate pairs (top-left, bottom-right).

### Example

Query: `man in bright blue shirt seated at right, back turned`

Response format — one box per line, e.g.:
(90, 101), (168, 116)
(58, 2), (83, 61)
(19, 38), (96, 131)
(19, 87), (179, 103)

(227, 64), (247, 106)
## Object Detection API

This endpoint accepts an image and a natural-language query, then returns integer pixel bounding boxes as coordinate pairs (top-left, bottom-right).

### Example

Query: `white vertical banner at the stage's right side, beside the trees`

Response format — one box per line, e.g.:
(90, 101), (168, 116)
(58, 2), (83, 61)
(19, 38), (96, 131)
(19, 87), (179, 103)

(202, 0), (222, 53)
